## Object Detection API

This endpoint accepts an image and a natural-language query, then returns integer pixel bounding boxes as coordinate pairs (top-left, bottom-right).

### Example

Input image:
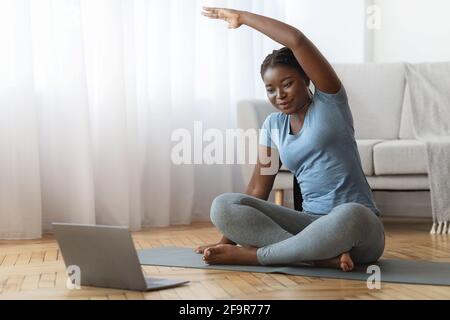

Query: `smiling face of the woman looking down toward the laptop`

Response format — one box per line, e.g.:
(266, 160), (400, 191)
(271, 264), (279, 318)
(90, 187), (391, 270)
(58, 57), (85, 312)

(263, 66), (310, 114)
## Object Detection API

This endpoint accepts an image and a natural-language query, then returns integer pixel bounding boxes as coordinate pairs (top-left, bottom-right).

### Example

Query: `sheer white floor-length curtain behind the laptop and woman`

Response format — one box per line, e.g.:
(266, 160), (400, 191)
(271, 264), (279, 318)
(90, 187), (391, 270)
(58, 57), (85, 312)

(0, 0), (285, 239)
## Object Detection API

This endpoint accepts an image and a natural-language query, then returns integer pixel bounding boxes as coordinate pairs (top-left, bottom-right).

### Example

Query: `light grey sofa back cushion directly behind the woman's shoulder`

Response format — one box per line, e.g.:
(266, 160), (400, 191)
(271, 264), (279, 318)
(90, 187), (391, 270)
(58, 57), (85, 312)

(333, 63), (405, 140)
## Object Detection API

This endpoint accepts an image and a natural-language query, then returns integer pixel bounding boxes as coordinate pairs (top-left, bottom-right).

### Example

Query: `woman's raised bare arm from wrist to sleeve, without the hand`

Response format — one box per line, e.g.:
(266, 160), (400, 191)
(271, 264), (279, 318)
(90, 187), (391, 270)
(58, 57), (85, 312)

(239, 11), (341, 94)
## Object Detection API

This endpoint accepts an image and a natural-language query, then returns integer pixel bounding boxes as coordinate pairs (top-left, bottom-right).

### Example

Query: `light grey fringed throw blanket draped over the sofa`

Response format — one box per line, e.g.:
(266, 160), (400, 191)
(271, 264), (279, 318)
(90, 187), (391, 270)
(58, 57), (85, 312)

(406, 62), (450, 234)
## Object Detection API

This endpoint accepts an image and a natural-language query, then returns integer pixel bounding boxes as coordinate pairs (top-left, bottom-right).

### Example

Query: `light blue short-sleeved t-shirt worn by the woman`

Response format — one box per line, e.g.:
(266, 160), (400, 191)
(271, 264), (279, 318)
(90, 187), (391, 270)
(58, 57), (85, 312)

(259, 86), (380, 215)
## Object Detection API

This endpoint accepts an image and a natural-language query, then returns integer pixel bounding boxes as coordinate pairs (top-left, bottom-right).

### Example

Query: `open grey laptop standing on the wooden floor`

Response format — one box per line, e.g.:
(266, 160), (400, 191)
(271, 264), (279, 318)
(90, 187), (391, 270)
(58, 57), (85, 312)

(52, 223), (189, 291)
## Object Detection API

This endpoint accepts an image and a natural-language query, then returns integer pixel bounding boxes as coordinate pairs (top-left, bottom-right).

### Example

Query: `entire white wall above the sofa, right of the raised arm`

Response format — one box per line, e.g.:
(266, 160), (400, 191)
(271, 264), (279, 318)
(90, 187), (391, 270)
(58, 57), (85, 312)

(282, 0), (450, 63)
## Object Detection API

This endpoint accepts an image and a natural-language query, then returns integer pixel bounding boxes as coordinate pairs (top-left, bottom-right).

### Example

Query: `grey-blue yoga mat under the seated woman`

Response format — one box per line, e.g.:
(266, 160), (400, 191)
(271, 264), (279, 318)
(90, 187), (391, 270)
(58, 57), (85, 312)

(138, 247), (450, 286)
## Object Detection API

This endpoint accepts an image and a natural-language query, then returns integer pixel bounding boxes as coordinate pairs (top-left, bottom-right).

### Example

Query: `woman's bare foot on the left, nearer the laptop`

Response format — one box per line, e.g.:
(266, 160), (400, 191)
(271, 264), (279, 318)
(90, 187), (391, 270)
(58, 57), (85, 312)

(203, 244), (259, 265)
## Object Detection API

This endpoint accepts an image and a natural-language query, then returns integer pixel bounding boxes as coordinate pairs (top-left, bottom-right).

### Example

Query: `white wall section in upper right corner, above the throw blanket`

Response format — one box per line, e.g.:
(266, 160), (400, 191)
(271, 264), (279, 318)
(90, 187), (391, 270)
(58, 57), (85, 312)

(373, 0), (450, 62)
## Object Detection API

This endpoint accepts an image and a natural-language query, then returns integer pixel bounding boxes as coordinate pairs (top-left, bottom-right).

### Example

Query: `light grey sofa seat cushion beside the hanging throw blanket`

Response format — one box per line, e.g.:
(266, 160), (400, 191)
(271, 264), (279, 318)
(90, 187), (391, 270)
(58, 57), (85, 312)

(373, 140), (428, 175)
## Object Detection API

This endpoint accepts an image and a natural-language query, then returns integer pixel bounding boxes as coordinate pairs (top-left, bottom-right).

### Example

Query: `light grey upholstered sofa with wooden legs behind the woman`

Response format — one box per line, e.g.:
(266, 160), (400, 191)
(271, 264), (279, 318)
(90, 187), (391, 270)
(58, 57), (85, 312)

(237, 63), (429, 208)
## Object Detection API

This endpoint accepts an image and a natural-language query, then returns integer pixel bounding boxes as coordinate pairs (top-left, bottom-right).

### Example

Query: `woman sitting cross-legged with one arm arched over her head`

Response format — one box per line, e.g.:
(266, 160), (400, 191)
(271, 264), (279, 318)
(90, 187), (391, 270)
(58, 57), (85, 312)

(195, 7), (385, 271)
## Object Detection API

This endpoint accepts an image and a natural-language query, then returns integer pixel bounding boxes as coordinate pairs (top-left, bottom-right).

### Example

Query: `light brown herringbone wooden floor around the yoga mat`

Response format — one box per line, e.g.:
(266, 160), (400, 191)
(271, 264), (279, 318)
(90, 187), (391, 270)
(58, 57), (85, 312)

(0, 220), (450, 299)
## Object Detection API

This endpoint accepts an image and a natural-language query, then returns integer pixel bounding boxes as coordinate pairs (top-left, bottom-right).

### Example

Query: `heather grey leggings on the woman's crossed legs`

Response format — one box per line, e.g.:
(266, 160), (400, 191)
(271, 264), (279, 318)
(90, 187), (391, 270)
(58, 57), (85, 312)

(211, 193), (385, 265)
